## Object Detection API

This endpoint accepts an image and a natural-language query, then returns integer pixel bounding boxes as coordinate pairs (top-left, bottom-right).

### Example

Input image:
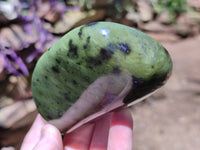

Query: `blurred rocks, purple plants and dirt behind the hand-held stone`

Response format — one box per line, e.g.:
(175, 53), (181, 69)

(0, 0), (200, 150)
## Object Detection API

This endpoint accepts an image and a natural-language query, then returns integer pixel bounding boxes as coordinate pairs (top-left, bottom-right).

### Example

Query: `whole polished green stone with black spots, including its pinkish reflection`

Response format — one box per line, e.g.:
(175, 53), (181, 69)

(32, 22), (172, 130)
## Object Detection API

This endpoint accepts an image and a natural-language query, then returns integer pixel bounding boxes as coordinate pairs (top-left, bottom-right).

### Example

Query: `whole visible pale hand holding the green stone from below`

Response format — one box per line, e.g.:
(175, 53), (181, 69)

(21, 109), (133, 150)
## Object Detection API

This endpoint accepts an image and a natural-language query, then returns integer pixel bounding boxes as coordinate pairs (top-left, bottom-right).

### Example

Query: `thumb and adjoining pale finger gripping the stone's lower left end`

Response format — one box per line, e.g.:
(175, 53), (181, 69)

(20, 114), (63, 150)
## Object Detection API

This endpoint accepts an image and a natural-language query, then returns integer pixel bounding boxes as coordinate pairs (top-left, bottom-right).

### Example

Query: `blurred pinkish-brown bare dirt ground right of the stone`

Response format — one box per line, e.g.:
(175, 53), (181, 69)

(131, 36), (200, 150)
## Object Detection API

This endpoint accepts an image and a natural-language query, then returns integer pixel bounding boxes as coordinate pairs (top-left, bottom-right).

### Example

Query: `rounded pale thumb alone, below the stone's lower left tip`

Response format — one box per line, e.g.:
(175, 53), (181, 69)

(33, 124), (63, 150)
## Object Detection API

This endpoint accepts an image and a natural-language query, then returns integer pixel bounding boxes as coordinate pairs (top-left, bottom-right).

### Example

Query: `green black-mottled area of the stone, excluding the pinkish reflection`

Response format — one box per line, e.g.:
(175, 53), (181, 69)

(32, 22), (172, 120)
